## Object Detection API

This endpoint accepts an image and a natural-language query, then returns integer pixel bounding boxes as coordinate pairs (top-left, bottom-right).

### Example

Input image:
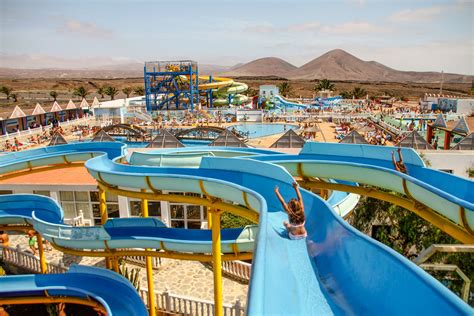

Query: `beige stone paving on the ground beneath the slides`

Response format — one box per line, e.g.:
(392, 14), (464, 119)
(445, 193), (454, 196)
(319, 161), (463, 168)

(5, 235), (248, 304)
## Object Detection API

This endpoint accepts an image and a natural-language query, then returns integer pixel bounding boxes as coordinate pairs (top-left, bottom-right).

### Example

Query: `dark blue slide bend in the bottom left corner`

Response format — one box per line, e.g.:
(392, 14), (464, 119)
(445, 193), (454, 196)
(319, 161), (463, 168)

(0, 265), (148, 316)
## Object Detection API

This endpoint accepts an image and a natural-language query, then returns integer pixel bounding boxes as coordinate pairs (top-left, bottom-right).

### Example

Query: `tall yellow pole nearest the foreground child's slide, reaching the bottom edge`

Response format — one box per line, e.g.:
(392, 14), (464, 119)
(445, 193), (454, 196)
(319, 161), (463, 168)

(211, 209), (223, 316)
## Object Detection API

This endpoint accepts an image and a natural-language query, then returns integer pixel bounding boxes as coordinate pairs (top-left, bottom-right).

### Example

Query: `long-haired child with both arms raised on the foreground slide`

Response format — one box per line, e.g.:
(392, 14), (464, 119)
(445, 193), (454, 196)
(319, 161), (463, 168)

(275, 182), (308, 240)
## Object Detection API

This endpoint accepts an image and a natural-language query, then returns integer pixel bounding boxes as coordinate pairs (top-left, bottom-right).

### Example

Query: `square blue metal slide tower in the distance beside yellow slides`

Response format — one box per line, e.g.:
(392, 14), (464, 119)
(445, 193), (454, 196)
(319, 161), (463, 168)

(144, 60), (199, 112)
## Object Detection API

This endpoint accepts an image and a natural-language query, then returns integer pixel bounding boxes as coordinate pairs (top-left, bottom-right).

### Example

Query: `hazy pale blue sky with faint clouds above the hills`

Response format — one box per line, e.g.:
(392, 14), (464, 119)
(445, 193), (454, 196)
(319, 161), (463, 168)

(0, 0), (474, 74)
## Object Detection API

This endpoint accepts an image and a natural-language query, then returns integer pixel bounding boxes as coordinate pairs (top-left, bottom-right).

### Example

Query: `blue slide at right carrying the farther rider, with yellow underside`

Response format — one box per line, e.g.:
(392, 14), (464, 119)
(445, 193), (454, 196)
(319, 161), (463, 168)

(254, 143), (474, 243)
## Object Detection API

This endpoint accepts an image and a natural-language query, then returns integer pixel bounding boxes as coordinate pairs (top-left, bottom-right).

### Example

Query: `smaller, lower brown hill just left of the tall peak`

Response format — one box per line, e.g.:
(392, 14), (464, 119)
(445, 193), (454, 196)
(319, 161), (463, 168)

(222, 57), (297, 77)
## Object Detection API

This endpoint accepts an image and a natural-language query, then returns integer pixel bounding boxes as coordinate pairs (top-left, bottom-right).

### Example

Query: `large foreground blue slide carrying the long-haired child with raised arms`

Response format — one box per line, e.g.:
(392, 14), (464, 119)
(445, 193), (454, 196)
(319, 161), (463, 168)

(0, 145), (472, 314)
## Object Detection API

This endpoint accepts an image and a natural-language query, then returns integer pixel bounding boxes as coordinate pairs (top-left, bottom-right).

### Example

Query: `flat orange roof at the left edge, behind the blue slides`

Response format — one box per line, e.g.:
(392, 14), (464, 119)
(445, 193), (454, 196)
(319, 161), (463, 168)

(0, 166), (97, 185)
